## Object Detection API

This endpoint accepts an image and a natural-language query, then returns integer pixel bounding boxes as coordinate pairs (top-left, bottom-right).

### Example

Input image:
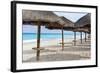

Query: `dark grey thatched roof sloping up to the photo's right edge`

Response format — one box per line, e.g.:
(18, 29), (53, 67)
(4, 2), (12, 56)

(75, 13), (91, 27)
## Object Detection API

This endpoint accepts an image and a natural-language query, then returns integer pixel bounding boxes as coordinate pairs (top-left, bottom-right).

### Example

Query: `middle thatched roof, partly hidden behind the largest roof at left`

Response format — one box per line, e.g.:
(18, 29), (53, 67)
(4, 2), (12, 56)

(46, 16), (74, 31)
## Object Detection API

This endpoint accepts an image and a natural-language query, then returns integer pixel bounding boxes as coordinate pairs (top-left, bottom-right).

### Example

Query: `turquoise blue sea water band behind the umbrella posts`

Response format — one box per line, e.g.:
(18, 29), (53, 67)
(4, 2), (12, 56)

(23, 33), (79, 40)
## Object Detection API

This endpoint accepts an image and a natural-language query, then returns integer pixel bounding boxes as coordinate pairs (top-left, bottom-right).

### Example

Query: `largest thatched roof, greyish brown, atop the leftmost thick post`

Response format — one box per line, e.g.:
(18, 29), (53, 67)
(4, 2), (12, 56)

(22, 10), (64, 26)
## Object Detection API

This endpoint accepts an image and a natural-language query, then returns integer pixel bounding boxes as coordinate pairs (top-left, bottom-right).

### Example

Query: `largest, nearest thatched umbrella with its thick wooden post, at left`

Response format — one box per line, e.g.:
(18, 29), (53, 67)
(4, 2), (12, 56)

(22, 10), (65, 61)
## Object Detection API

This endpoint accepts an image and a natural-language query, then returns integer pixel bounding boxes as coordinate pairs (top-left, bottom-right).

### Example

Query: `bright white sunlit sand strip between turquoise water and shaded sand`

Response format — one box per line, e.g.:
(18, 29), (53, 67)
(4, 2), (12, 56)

(23, 39), (73, 50)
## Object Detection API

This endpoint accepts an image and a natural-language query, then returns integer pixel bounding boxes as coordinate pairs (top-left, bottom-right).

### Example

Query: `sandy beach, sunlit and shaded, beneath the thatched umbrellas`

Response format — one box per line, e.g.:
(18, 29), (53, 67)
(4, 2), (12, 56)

(23, 39), (91, 63)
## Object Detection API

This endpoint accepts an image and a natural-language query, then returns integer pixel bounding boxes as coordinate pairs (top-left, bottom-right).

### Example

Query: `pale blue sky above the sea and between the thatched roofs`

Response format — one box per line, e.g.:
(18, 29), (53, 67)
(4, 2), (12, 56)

(23, 12), (87, 33)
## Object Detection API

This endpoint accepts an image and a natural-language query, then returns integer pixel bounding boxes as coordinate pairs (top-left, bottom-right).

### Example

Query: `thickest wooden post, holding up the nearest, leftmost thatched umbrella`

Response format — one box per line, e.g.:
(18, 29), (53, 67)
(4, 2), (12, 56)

(36, 22), (41, 61)
